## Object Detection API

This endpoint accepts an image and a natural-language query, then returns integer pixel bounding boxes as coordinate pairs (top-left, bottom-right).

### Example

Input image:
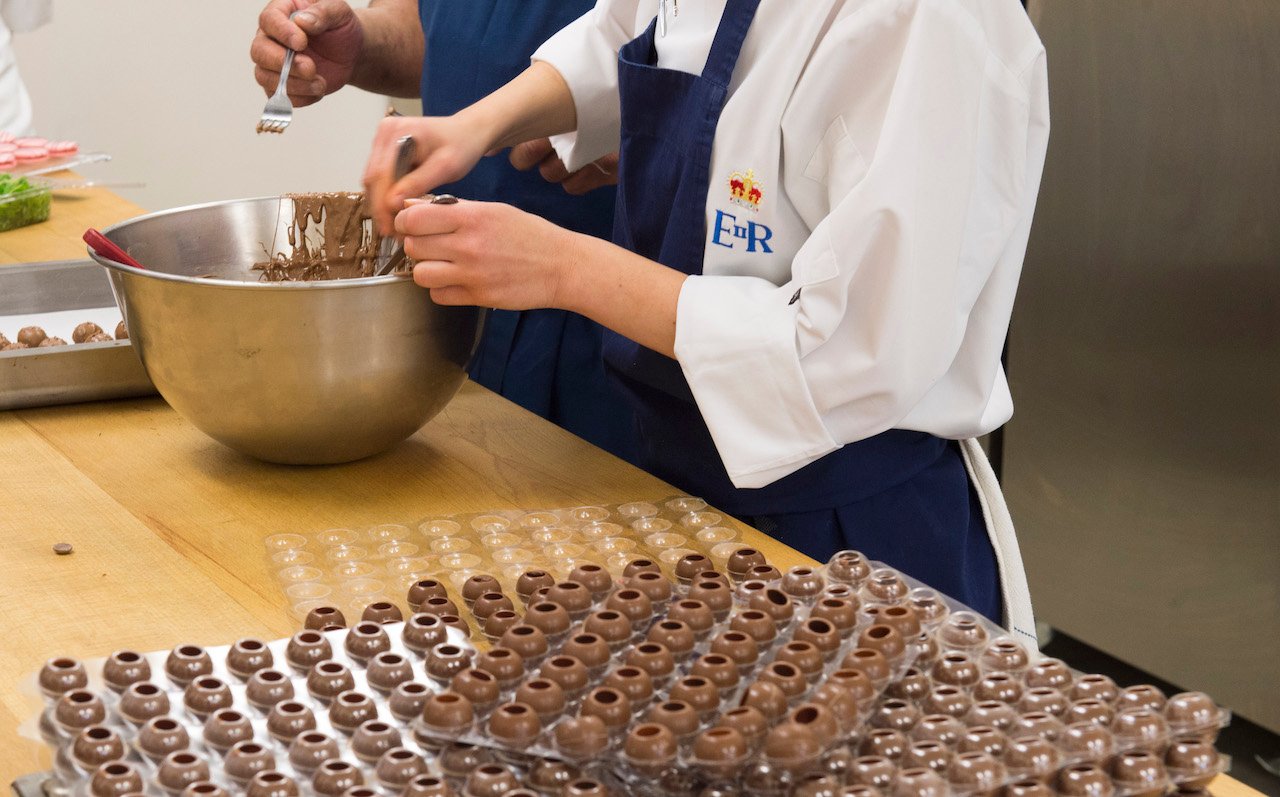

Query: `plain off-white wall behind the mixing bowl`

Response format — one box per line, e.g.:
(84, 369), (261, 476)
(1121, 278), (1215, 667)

(14, 0), (387, 210)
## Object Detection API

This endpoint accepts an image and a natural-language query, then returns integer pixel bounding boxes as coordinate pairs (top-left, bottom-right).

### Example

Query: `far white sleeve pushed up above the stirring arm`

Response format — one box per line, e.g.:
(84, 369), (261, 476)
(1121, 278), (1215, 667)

(532, 0), (657, 171)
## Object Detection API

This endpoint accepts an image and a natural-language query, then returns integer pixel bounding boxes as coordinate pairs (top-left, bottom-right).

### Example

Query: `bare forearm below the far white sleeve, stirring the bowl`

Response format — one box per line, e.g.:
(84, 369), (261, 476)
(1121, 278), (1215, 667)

(458, 61), (577, 150)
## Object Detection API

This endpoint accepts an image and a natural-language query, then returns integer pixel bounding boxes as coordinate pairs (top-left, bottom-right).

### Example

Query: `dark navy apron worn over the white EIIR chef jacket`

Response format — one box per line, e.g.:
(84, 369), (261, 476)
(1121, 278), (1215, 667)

(604, 0), (1001, 622)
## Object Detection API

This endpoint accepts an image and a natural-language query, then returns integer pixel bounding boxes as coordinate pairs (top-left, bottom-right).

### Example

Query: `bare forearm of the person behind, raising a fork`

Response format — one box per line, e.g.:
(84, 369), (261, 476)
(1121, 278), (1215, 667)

(351, 0), (425, 97)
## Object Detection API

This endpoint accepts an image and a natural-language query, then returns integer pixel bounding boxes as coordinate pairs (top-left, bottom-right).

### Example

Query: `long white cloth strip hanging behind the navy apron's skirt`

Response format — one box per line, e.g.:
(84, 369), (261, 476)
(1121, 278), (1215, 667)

(960, 438), (1039, 655)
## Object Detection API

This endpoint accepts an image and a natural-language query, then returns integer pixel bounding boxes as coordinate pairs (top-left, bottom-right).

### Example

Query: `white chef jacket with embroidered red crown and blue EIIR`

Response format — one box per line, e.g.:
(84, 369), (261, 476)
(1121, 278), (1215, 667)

(534, 0), (1048, 487)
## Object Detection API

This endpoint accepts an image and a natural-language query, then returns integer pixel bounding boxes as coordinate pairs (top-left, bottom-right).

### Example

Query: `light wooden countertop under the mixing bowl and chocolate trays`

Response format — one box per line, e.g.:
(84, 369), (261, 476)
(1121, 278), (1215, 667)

(0, 191), (1257, 797)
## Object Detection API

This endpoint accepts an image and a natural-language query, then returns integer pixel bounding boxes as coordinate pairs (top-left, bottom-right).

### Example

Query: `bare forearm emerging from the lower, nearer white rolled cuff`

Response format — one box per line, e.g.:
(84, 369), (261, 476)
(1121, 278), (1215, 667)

(557, 234), (686, 357)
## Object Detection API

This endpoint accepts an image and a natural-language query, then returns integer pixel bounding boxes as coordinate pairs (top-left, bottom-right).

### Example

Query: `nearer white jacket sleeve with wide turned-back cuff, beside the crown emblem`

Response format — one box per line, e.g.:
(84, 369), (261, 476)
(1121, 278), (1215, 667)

(676, 3), (1034, 487)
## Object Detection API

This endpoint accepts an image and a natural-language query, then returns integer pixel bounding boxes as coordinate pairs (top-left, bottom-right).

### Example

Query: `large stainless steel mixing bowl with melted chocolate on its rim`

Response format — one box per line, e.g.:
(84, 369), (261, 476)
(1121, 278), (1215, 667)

(90, 197), (480, 464)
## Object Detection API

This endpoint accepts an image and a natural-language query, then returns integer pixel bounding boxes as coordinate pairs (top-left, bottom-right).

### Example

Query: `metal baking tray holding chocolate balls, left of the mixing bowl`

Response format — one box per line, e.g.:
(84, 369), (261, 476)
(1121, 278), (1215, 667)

(0, 260), (156, 409)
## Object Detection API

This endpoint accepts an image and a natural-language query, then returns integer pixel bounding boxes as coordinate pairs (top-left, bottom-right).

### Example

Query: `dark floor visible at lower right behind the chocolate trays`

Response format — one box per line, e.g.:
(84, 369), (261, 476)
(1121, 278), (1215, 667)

(1042, 629), (1280, 796)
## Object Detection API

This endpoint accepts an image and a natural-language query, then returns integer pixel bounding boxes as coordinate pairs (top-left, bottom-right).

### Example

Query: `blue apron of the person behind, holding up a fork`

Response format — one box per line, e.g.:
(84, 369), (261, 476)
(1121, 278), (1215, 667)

(419, 0), (635, 459)
